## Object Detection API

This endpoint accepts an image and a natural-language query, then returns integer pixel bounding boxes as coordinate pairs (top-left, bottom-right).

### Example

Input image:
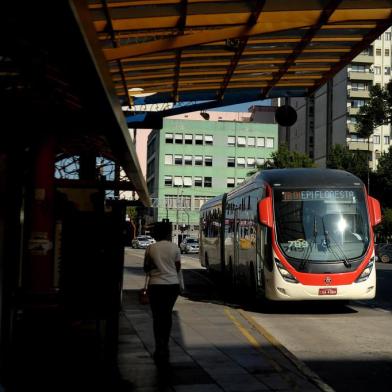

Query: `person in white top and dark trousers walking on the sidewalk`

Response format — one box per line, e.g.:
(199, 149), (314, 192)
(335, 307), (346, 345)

(143, 222), (181, 365)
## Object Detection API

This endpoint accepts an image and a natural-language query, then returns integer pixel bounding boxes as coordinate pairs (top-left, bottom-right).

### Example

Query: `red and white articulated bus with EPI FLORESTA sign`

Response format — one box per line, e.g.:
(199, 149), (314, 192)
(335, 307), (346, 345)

(200, 169), (381, 301)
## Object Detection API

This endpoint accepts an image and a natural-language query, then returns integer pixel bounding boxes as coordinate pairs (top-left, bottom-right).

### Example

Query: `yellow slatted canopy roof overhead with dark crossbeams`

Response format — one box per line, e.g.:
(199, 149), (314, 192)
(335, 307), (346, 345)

(89, 0), (392, 110)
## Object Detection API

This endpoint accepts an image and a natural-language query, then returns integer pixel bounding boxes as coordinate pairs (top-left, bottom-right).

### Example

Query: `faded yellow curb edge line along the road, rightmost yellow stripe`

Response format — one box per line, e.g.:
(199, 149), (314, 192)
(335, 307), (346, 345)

(238, 309), (334, 392)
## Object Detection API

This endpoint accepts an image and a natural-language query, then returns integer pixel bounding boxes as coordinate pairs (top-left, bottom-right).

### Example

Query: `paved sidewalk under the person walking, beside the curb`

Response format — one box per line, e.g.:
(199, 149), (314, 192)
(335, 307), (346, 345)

(118, 250), (332, 392)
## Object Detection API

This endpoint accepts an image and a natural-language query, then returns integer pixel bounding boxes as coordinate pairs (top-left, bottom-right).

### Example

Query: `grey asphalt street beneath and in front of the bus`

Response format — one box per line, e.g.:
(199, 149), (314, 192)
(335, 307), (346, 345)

(125, 249), (392, 391)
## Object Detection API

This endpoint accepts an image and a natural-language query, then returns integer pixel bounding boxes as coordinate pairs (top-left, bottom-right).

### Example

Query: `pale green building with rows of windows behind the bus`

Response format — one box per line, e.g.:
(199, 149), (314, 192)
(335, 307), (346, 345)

(147, 115), (278, 240)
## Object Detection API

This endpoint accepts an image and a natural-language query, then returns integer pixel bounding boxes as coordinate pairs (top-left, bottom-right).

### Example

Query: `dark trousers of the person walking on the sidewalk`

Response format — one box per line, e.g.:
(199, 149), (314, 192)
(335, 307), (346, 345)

(148, 284), (180, 356)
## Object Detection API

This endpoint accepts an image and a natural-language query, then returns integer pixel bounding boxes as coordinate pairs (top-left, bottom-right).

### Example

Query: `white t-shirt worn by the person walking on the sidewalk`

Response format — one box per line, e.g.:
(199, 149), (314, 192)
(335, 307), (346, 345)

(144, 241), (181, 284)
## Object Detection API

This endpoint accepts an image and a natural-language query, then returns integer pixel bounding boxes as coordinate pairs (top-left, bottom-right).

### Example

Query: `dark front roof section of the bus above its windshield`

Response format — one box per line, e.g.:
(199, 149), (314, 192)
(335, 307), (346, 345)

(254, 168), (363, 188)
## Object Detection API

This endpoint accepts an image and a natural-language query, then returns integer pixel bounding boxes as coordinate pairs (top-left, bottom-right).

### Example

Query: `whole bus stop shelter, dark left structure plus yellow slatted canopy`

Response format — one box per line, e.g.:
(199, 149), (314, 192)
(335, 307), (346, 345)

(0, 0), (392, 383)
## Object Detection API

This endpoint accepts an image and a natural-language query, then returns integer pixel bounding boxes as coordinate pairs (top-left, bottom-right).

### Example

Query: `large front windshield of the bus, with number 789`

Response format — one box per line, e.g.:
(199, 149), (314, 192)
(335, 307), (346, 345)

(274, 188), (369, 262)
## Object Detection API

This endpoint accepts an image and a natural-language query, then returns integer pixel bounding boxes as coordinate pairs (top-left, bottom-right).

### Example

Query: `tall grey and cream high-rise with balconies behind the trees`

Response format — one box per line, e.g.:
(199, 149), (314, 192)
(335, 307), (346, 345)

(279, 29), (392, 169)
